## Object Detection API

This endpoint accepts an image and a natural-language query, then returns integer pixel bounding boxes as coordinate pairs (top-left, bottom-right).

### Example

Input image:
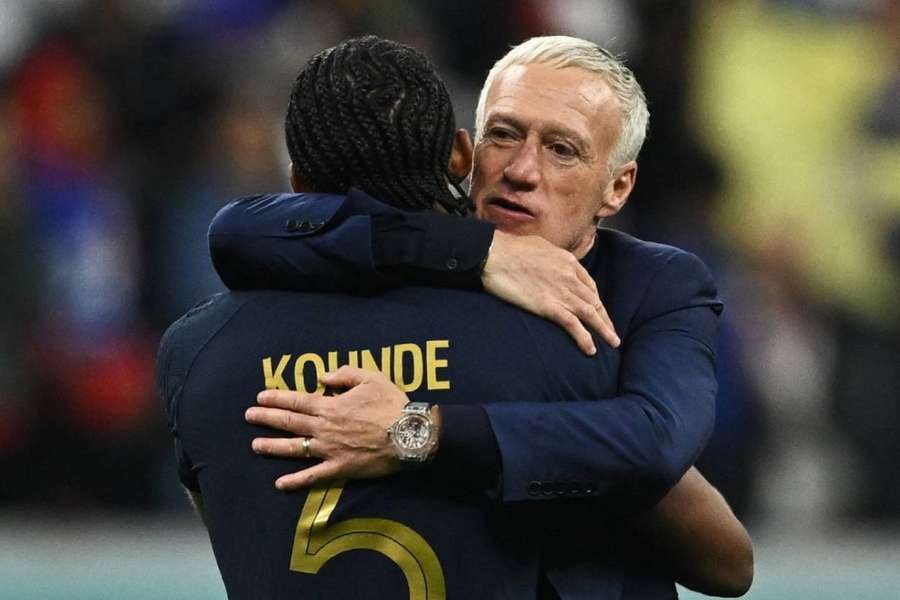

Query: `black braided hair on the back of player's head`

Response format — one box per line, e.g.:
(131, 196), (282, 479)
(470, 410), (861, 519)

(285, 35), (471, 214)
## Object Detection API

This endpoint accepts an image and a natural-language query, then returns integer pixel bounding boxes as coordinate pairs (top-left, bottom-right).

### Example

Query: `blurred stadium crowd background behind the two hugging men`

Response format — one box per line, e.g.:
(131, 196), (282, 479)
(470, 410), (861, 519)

(0, 0), (900, 600)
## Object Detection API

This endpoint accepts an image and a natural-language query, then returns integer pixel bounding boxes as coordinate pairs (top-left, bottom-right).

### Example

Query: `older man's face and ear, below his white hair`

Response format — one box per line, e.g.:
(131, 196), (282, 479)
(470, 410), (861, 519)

(472, 64), (636, 257)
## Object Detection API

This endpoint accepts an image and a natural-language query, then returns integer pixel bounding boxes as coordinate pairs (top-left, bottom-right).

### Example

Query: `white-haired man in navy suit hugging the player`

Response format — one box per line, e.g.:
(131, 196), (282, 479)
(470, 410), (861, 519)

(210, 36), (744, 598)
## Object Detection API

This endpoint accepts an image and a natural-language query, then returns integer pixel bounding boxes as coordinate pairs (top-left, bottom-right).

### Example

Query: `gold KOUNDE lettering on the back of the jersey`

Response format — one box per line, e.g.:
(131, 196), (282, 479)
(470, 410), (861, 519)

(262, 340), (450, 393)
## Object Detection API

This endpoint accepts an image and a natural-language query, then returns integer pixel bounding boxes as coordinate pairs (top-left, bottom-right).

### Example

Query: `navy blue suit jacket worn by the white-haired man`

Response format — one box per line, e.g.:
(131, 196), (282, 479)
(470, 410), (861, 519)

(210, 192), (721, 598)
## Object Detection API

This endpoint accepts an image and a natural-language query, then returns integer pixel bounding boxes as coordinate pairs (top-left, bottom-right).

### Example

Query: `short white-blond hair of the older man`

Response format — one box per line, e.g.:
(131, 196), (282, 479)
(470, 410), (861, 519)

(475, 35), (650, 170)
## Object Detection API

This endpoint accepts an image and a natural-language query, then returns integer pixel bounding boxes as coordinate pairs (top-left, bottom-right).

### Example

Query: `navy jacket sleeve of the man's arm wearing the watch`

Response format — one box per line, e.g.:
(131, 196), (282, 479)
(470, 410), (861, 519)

(485, 252), (721, 506)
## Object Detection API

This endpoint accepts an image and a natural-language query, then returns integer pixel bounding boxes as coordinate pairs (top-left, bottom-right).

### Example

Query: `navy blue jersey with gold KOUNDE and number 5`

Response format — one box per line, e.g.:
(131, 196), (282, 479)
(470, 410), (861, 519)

(158, 288), (619, 600)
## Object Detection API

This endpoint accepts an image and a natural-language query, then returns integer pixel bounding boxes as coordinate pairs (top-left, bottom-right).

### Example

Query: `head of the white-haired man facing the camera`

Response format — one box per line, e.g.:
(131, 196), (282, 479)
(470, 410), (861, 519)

(472, 36), (649, 253)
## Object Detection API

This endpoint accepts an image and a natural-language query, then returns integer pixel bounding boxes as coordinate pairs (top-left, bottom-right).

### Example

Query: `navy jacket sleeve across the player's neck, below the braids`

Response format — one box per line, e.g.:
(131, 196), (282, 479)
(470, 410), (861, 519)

(209, 189), (494, 291)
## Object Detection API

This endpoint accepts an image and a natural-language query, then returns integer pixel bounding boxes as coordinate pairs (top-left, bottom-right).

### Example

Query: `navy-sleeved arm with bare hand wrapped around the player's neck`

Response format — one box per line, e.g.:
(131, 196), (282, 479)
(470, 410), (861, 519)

(209, 189), (619, 354)
